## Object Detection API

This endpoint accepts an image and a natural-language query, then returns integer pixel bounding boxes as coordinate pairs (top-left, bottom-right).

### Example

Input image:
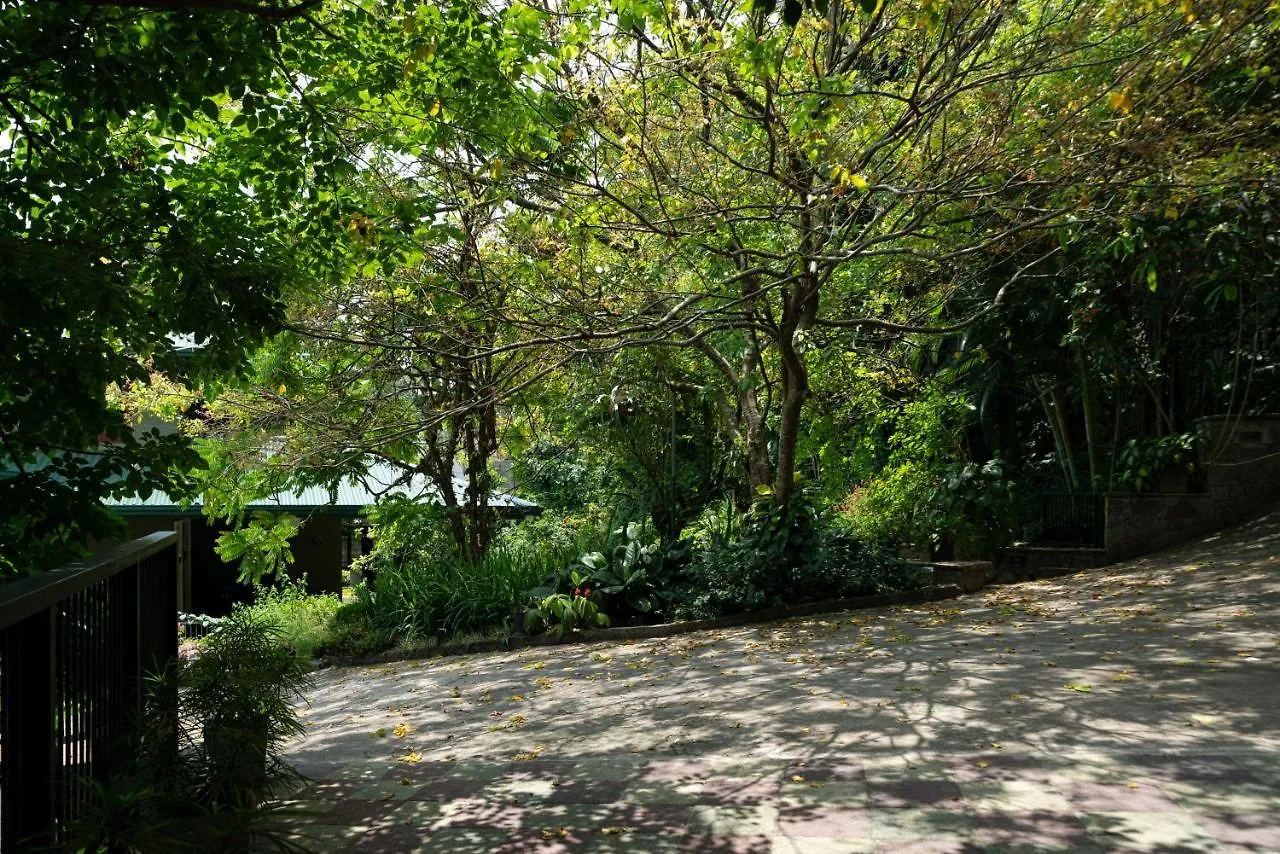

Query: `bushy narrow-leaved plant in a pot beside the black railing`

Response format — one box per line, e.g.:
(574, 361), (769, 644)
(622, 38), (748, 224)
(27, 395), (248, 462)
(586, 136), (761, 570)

(180, 609), (311, 802)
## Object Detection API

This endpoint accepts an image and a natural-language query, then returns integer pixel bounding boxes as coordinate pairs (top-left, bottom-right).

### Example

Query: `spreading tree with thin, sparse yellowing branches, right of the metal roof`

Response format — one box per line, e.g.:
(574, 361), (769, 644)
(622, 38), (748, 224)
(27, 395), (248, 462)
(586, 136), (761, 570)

(509, 0), (1208, 502)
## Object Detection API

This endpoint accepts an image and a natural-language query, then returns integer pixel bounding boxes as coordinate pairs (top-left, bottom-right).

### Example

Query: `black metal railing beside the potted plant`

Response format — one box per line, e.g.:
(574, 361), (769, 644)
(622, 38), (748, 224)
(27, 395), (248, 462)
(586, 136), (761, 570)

(0, 531), (178, 851)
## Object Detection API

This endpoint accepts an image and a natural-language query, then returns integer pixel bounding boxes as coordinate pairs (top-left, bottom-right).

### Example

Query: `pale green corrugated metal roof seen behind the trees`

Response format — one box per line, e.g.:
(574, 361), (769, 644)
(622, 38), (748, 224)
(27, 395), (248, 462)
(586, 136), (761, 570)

(105, 463), (538, 515)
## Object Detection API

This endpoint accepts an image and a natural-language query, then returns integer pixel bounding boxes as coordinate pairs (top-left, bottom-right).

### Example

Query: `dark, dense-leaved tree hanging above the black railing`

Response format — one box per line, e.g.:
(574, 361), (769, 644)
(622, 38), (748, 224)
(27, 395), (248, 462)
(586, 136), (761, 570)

(0, 3), (340, 574)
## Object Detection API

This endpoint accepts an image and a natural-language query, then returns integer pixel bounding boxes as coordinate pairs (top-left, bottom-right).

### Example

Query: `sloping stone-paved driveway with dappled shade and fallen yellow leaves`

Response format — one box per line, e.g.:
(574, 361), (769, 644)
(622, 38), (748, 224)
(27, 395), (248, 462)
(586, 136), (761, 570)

(280, 513), (1280, 854)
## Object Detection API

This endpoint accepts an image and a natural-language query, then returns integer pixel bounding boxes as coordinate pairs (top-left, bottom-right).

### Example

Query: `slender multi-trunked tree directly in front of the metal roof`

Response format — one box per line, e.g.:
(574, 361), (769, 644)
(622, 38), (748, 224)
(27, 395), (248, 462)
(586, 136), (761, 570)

(193, 3), (576, 557)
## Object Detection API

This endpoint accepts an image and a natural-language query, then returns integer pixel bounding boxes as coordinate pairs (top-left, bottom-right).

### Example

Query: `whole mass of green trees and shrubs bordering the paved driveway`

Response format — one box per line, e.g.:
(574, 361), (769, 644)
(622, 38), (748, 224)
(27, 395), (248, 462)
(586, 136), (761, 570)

(10, 0), (1280, 649)
